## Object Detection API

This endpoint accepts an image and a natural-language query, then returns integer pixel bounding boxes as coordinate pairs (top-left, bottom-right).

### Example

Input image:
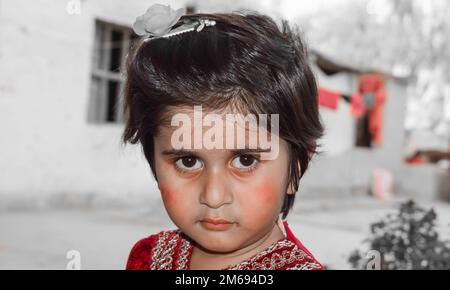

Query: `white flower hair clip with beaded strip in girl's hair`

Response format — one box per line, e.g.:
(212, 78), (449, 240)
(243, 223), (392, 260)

(133, 4), (216, 42)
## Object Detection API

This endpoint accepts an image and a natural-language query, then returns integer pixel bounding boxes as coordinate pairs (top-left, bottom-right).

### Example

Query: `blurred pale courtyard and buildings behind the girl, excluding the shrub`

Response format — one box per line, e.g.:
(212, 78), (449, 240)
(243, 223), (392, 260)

(0, 0), (450, 269)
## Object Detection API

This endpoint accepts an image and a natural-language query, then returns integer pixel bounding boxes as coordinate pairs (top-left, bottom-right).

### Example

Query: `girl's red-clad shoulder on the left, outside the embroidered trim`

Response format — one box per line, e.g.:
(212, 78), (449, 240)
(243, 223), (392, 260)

(126, 230), (175, 270)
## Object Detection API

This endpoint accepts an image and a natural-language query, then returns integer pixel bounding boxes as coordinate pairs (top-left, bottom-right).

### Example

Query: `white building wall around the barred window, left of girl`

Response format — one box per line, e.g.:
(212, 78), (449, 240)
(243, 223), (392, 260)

(0, 0), (195, 205)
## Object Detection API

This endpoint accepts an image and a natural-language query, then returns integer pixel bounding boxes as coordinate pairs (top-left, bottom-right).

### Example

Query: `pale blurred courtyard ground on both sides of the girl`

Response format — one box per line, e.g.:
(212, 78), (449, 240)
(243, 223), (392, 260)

(0, 195), (450, 269)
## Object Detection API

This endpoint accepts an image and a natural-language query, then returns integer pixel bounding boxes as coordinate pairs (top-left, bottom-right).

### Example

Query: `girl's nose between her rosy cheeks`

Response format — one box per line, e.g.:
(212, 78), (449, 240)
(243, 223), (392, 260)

(200, 167), (233, 209)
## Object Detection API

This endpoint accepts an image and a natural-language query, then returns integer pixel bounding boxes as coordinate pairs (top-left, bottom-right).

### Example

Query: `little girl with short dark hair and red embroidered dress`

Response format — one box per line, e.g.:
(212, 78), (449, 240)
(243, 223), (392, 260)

(123, 4), (323, 270)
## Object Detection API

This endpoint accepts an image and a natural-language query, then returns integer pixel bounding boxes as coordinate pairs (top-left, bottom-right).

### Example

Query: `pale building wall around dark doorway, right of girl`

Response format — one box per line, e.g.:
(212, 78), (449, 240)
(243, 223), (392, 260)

(300, 71), (406, 195)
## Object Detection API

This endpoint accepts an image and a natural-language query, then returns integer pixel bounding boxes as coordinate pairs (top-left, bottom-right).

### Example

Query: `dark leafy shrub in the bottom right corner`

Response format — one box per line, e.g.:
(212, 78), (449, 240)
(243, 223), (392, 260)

(349, 201), (450, 270)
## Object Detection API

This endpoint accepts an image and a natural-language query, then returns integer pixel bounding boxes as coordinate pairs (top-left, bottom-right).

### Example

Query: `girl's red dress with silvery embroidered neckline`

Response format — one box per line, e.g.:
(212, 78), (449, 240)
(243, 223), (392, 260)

(126, 221), (324, 270)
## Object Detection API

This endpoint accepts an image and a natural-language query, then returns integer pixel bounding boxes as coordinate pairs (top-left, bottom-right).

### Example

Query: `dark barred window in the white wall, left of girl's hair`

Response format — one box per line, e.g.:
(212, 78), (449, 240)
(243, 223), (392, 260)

(88, 20), (137, 123)
